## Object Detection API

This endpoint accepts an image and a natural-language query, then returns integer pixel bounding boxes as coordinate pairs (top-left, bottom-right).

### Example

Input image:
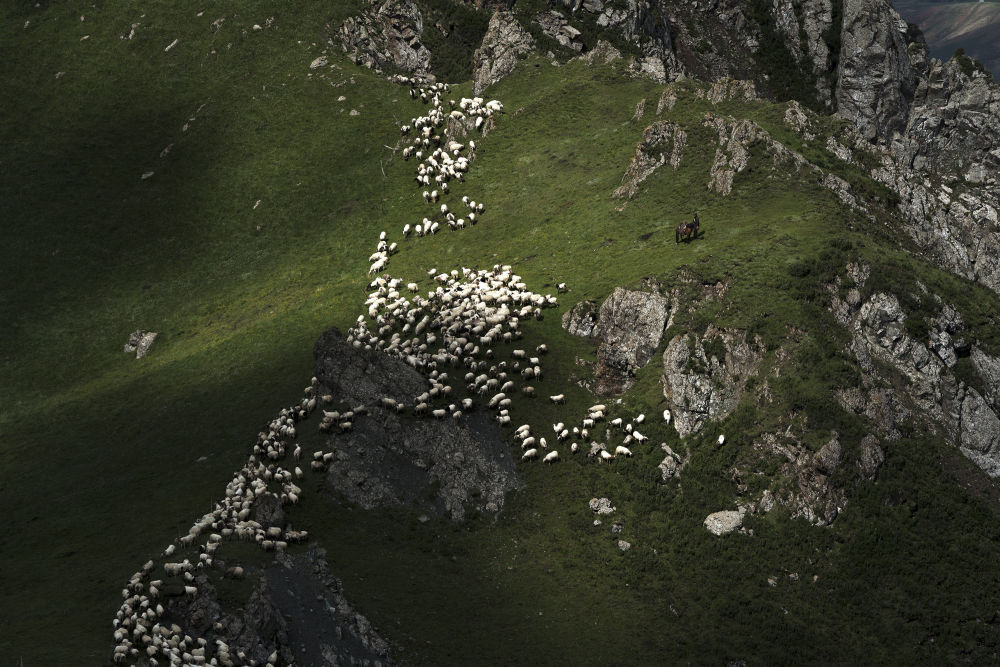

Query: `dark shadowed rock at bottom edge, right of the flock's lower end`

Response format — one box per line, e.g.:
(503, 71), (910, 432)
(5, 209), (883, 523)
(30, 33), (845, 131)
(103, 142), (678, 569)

(162, 547), (393, 667)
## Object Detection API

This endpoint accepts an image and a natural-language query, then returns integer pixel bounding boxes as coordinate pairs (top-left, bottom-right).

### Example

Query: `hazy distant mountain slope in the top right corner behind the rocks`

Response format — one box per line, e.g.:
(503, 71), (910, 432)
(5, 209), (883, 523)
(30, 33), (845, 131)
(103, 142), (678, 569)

(893, 0), (1000, 77)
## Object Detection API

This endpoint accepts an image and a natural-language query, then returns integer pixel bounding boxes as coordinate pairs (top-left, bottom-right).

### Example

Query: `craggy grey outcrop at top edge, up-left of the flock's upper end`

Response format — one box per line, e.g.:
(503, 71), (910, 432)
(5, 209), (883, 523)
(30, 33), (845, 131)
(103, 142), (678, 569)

(340, 0), (432, 78)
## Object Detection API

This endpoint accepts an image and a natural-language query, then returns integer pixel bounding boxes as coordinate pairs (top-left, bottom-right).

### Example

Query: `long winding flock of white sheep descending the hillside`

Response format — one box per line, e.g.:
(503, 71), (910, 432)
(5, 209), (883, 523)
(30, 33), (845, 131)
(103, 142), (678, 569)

(105, 77), (692, 667)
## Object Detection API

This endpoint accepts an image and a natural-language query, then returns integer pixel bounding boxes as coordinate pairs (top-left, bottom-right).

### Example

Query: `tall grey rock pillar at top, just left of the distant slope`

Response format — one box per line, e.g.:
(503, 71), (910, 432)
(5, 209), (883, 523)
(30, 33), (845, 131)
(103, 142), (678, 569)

(836, 0), (924, 139)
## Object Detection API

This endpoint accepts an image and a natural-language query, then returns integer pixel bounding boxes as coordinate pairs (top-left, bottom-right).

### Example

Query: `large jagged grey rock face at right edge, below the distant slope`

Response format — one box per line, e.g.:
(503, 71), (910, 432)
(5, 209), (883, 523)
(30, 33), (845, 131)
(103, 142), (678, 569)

(835, 58), (1000, 292)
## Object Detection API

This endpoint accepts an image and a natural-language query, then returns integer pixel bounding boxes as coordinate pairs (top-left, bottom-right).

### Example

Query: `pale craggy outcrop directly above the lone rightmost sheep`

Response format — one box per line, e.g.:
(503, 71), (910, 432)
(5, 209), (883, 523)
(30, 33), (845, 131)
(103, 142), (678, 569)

(663, 327), (764, 437)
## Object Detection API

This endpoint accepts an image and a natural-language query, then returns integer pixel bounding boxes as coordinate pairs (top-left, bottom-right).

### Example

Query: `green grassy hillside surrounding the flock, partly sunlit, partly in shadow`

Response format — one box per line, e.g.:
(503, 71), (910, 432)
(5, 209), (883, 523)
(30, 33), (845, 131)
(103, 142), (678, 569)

(0, 1), (1000, 665)
